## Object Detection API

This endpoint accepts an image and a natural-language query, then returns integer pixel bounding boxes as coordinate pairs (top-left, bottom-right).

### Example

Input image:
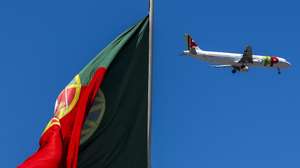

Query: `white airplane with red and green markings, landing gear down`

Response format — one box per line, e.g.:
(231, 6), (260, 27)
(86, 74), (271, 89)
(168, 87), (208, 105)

(183, 34), (291, 74)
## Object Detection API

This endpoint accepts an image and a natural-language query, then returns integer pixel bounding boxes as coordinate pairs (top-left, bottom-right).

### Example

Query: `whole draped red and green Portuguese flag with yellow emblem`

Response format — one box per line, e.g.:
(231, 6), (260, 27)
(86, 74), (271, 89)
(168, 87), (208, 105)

(19, 16), (149, 168)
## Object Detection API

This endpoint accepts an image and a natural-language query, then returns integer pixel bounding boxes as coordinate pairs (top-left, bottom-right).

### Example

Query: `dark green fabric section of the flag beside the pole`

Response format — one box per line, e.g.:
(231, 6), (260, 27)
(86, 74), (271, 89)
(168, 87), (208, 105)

(78, 17), (149, 168)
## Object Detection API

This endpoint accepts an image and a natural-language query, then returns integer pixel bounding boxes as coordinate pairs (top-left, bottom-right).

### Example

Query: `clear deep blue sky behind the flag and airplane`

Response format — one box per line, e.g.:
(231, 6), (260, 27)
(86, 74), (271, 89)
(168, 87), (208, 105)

(0, 0), (300, 168)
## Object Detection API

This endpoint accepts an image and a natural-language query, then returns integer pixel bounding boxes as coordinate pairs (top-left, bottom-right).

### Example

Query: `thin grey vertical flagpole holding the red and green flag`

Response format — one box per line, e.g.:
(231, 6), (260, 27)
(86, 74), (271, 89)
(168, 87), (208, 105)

(147, 0), (154, 168)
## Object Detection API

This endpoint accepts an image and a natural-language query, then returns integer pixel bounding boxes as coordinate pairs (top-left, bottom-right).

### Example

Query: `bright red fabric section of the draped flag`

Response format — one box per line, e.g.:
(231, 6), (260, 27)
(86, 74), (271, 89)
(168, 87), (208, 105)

(19, 67), (106, 168)
